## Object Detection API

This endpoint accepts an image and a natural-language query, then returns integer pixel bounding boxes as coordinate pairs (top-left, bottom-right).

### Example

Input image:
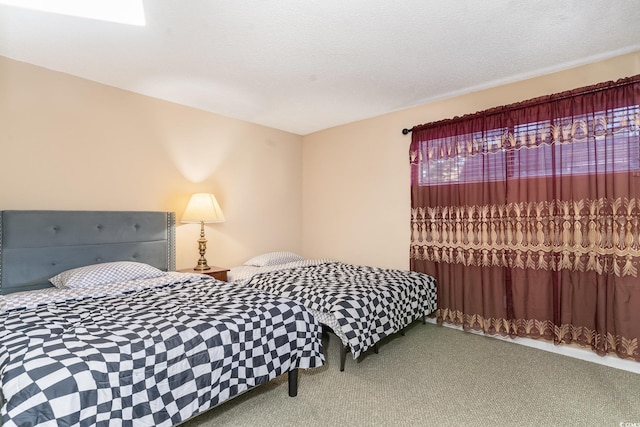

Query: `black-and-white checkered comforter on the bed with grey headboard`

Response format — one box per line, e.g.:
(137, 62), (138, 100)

(0, 276), (324, 427)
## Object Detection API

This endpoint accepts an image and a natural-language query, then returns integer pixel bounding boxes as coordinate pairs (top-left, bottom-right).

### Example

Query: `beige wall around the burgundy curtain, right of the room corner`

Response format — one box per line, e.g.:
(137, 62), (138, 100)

(302, 52), (640, 269)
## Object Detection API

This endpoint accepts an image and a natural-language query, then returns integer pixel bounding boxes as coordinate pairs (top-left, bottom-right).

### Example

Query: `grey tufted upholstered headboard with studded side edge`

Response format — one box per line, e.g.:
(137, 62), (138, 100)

(0, 210), (175, 294)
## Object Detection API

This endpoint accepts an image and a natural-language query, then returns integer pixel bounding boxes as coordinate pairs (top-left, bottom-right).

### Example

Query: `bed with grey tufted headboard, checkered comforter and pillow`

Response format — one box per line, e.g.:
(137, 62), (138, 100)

(0, 211), (324, 426)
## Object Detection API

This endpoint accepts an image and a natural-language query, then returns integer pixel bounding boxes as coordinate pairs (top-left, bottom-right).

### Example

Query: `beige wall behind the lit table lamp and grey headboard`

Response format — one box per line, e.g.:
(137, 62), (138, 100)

(0, 57), (302, 268)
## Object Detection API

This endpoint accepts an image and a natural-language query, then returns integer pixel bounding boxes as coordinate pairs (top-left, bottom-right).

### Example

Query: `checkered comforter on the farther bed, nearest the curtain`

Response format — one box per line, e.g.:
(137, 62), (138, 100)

(246, 262), (436, 359)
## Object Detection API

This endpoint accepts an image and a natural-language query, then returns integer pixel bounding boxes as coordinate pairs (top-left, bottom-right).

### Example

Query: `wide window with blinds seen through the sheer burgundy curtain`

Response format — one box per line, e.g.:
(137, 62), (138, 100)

(418, 105), (640, 185)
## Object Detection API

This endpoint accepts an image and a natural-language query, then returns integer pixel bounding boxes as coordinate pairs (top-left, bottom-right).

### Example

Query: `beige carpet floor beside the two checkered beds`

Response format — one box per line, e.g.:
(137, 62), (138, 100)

(183, 322), (640, 427)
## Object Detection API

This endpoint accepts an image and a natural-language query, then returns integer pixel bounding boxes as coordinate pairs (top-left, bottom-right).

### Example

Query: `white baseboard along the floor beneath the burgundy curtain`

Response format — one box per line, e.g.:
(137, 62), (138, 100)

(426, 318), (640, 374)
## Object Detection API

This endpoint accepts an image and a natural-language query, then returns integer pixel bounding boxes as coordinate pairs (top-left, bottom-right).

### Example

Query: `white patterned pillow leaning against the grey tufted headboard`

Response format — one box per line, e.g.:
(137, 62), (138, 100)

(49, 261), (167, 288)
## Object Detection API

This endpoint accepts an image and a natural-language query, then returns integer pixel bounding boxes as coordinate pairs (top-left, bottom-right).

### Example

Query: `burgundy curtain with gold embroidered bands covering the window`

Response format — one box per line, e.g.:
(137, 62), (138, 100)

(410, 76), (640, 361)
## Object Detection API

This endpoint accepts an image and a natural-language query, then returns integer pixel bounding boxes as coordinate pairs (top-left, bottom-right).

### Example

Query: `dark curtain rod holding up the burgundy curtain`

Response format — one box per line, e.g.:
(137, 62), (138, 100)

(402, 74), (640, 135)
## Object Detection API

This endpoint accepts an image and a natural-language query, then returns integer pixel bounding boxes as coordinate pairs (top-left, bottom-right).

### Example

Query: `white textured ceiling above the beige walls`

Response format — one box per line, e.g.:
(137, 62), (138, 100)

(0, 0), (640, 135)
